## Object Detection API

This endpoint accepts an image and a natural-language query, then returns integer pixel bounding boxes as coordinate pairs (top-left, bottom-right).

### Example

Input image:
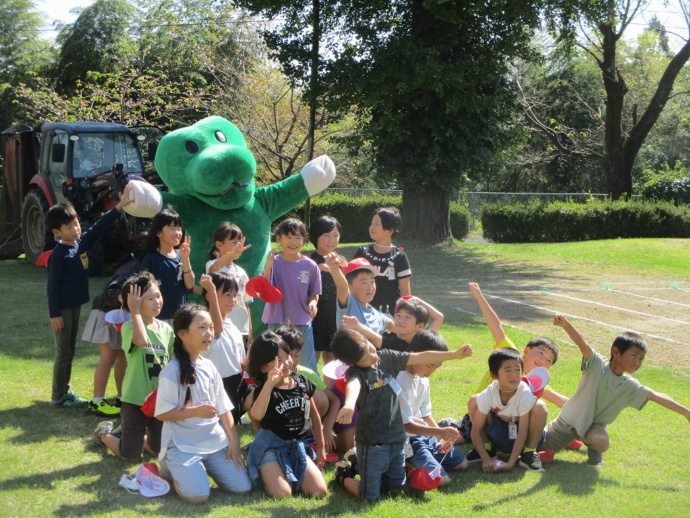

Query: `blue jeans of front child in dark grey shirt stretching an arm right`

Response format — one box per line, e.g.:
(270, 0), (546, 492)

(357, 443), (407, 500)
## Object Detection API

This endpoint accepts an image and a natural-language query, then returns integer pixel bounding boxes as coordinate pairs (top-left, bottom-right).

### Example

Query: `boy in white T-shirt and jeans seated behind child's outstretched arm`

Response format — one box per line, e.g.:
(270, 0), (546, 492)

(396, 329), (468, 486)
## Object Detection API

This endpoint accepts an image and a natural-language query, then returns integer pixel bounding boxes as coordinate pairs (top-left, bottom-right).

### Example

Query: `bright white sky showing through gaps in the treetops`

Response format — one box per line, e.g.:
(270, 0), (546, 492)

(36, 0), (688, 41)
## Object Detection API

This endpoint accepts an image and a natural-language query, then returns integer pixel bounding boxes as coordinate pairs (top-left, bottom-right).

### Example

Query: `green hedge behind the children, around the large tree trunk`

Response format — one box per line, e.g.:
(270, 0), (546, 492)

(276, 193), (469, 243)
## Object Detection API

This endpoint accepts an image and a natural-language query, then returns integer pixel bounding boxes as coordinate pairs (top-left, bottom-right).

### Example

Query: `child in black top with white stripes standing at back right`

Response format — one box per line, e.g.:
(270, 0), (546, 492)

(352, 207), (412, 315)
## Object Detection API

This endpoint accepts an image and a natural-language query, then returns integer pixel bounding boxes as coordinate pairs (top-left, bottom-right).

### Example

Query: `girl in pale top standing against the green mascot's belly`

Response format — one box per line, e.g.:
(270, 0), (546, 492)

(206, 221), (254, 348)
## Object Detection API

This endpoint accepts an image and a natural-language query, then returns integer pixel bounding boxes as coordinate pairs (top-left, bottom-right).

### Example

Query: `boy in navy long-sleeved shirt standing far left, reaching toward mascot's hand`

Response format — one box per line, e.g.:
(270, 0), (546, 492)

(46, 185), (132, 407)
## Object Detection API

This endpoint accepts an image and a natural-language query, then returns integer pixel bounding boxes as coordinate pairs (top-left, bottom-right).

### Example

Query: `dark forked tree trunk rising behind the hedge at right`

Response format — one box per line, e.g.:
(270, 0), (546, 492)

(550, 0), (690, 199)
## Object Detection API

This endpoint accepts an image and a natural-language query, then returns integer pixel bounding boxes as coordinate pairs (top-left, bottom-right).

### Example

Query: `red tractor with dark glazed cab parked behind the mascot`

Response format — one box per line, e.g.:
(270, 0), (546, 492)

(0, 122), (158, 275)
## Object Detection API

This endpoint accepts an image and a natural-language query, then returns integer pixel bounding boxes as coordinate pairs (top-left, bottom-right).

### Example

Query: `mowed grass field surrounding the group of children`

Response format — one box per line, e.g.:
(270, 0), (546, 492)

(0, 240), (690, 517)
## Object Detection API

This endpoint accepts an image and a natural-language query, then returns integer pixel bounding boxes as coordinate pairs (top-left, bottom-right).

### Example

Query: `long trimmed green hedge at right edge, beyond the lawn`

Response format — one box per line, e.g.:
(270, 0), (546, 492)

(481, 200), (690, 243)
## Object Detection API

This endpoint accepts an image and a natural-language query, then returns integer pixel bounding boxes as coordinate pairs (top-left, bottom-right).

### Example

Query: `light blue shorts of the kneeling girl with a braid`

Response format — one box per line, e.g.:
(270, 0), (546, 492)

(165, 444), (252, 497)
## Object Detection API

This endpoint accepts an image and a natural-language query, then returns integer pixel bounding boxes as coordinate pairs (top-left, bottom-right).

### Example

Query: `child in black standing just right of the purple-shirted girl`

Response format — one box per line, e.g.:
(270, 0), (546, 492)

(309, 216), (343, 365)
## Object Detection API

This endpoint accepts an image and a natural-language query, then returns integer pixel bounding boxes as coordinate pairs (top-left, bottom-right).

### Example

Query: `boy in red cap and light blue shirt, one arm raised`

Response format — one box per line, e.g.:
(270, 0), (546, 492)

(326, 252), (394, 334)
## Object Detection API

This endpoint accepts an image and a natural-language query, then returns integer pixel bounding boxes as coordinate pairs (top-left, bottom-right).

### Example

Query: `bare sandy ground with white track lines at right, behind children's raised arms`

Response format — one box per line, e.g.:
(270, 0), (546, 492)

(429, 272), (690, 370)
